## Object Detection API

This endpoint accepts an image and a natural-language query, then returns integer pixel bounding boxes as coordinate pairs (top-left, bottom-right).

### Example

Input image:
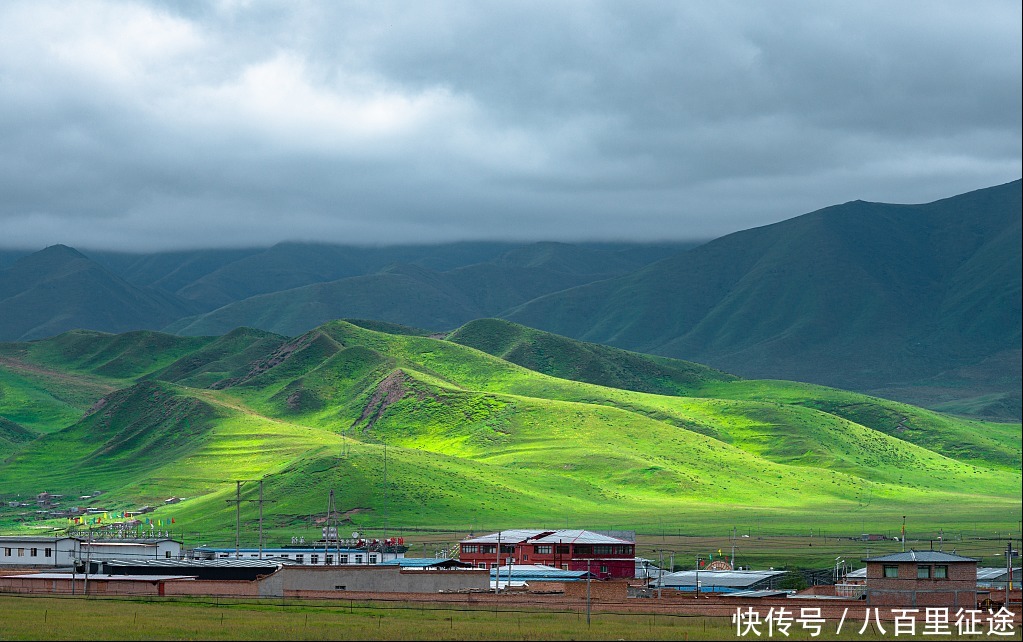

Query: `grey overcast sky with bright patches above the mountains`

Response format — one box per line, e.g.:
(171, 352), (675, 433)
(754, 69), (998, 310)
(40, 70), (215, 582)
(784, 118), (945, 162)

(0, 0), (1023, 251)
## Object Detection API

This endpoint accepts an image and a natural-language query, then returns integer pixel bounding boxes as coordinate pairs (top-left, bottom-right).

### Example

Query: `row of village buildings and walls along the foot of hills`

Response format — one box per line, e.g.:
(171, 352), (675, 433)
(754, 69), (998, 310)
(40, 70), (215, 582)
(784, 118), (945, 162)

(0, 519), (1021, 634)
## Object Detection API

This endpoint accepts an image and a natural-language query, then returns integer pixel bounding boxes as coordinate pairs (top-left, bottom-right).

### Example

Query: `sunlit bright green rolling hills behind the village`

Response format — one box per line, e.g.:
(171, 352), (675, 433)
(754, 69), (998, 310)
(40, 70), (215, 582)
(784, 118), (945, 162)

(0, 320), (1021, 542)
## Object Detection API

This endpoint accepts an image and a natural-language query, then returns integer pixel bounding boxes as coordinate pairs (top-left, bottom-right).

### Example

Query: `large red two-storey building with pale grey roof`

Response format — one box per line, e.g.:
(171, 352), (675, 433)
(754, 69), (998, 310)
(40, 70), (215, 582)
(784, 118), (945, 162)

(458, 530), (635, 580)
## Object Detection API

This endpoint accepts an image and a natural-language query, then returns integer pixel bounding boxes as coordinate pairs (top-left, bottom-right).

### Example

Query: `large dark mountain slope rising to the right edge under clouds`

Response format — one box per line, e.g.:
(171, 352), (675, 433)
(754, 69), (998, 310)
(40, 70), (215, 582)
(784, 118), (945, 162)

(503, 181), (1021, 416)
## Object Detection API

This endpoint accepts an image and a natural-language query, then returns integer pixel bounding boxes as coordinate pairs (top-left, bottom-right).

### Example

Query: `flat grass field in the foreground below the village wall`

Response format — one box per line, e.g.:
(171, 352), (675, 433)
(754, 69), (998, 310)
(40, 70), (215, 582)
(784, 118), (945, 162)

(0, 596), (905, 641)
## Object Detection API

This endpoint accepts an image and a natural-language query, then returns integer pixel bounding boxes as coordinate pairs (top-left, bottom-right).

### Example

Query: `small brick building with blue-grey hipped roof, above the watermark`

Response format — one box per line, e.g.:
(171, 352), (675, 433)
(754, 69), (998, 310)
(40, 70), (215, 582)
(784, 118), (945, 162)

(863, 550), (977, 608)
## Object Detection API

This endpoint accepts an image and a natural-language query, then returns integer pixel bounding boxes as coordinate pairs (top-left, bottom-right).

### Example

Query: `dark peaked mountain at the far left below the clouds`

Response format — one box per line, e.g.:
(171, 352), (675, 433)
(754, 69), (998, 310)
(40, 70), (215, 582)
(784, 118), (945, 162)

(0, 245), (194, 340)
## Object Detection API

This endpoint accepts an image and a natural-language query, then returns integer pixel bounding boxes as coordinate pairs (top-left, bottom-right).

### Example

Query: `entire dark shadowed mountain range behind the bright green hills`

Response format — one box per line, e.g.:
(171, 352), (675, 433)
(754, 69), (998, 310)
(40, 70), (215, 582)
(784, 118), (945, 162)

(0, 181), (1023, 420)
